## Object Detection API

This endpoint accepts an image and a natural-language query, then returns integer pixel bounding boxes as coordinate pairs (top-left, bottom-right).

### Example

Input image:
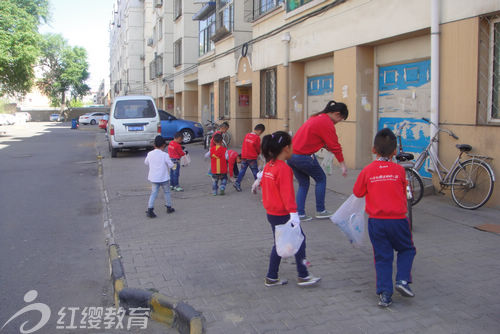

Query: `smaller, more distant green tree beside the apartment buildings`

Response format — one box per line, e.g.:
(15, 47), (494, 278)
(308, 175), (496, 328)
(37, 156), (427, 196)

(37, 34), (90, 108)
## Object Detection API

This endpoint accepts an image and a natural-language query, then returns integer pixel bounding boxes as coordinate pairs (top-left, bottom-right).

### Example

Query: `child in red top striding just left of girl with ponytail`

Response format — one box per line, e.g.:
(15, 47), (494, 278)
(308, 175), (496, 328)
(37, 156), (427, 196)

(233, 124), (266, 191)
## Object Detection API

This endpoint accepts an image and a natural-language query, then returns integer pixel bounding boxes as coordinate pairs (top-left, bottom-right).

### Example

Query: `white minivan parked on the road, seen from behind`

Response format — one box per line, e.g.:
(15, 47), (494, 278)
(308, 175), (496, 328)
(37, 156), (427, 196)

(107, 95), (161, 158)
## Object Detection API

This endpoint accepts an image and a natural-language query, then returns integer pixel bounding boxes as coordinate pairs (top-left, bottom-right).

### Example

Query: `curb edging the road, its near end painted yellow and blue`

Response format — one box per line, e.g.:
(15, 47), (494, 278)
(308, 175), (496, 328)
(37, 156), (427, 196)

(96, 140), (206, 334)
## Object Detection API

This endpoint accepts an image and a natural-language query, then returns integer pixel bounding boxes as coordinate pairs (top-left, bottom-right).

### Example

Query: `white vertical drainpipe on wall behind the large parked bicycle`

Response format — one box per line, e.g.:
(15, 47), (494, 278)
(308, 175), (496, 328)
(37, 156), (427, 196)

(430, 0), (440, 155)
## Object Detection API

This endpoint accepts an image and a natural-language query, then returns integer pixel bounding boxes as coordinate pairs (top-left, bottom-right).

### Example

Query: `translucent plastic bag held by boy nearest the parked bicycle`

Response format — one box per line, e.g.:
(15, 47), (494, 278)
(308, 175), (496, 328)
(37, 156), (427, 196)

(330, 195), (366, 247)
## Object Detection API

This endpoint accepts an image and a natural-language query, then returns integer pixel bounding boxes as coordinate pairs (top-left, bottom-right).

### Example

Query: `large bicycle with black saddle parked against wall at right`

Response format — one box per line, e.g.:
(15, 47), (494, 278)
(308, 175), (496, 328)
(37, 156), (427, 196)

(413, 117), (495, 210)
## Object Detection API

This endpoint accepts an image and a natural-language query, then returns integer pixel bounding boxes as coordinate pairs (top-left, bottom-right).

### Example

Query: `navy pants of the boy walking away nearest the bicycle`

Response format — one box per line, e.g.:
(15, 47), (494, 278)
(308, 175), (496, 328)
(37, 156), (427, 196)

(368, 218), (417, 294)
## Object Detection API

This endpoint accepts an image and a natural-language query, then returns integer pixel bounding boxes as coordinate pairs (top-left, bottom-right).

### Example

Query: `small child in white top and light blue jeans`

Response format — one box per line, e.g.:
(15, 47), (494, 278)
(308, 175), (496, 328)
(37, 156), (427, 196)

(144, 136), (175, 218)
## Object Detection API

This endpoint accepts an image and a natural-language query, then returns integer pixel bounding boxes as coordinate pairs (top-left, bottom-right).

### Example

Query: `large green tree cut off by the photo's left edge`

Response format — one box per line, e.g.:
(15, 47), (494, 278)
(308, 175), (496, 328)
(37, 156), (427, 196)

(0, 0), (49, 95)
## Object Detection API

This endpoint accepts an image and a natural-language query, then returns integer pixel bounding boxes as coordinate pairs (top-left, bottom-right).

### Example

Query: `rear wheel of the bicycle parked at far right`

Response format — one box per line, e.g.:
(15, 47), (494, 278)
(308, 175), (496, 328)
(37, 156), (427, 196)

(451, 159), (494, 210)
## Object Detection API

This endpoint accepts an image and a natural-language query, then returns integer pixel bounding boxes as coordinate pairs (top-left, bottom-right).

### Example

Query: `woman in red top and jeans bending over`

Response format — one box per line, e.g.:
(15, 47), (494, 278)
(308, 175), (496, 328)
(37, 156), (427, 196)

(288, 101), (349, 221)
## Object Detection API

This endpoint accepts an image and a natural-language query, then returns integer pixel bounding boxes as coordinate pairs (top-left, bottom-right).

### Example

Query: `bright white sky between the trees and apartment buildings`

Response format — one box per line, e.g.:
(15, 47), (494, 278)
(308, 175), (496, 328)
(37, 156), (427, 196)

(39, 0), (114, 92)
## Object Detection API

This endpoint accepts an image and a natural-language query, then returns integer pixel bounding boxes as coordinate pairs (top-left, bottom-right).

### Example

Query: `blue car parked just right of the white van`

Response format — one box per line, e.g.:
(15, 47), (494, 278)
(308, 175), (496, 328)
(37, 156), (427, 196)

(158, 109), (203, 144)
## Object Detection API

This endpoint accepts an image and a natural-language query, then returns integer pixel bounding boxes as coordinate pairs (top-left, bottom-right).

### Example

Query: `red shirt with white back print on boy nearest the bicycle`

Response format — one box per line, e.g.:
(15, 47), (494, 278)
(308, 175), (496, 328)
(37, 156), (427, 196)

(352, 160), (407, 219)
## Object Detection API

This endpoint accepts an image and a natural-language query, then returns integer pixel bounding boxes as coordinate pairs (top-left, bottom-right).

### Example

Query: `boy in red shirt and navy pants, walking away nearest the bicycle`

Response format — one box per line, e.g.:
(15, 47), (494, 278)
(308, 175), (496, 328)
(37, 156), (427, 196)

(353, 128), (416, 307)
